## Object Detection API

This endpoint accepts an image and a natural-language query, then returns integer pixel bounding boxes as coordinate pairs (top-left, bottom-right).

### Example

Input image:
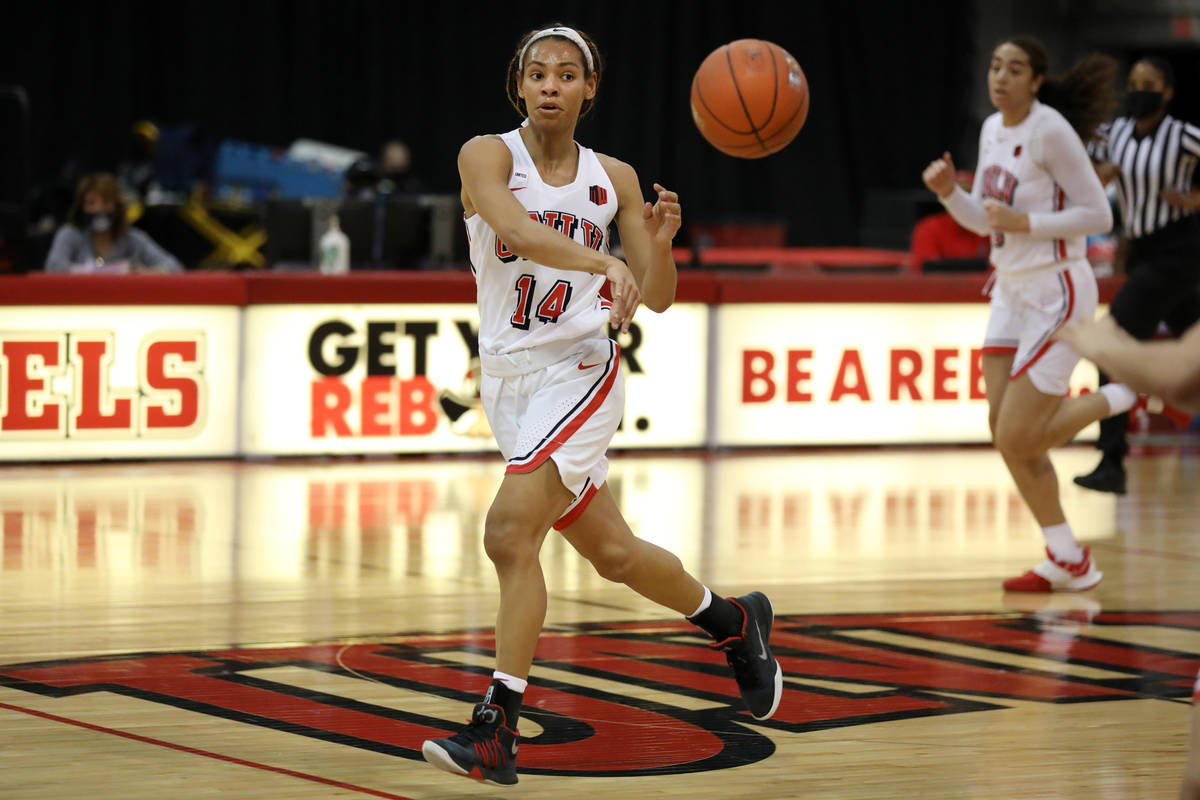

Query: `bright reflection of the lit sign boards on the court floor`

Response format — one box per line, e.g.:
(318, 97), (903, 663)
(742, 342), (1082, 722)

(0, 449), (1118, 590)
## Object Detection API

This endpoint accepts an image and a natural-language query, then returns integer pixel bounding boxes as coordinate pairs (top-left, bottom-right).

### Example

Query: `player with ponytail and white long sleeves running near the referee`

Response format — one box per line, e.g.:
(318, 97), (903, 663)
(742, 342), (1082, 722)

(923, 38), (1136, 591)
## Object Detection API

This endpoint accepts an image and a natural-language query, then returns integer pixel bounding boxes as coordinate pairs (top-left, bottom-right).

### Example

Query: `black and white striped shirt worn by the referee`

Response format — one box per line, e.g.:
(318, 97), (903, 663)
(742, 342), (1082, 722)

(1087, 114), (1200, 239)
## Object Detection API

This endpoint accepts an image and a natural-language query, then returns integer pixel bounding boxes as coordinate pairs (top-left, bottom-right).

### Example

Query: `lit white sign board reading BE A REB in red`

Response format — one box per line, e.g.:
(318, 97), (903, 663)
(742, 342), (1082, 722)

(714, 303), (1097, 446)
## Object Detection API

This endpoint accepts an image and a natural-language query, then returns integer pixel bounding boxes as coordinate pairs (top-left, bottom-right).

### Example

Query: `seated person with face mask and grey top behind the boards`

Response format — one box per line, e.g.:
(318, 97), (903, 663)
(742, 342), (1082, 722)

(46, 173), (184, 273)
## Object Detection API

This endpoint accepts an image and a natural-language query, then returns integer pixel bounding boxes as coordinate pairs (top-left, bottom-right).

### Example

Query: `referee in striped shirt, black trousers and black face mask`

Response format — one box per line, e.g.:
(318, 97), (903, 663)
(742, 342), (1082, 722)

(1075, 56), (1200, 494)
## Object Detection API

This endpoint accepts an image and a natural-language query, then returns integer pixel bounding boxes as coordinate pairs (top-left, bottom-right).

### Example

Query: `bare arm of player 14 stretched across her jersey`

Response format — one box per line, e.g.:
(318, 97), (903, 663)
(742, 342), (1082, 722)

(458, 136), (641, 326)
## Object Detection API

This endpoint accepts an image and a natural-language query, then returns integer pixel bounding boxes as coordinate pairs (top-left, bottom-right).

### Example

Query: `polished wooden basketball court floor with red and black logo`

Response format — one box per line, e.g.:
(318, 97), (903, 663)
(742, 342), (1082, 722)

(0, 447), (1200, 800)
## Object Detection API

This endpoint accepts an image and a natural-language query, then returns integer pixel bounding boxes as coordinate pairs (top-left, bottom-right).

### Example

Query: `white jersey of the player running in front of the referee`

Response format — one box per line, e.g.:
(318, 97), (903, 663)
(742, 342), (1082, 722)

(972, 101), (1087, 272)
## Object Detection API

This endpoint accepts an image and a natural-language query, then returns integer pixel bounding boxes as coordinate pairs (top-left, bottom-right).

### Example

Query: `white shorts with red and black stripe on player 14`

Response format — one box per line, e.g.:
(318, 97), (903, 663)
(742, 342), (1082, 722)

(480, 337), (625, 530)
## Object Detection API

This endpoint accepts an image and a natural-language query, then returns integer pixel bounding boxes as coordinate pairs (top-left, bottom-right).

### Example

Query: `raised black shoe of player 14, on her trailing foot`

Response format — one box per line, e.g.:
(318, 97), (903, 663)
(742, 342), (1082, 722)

(710, 591), (784, 720)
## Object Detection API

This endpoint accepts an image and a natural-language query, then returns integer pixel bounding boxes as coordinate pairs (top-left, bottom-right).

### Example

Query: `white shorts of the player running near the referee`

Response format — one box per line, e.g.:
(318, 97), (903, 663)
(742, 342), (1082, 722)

(983, 259), (1098, 395)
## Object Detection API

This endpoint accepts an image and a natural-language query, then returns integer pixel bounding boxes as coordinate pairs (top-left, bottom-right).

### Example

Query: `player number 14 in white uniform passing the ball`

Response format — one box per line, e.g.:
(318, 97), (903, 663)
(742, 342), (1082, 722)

(421, 25), (782, 784)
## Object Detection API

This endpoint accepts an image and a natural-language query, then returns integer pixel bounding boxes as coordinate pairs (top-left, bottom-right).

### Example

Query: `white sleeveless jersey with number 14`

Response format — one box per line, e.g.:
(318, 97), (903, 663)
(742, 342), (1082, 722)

(466, 131), (617, 361)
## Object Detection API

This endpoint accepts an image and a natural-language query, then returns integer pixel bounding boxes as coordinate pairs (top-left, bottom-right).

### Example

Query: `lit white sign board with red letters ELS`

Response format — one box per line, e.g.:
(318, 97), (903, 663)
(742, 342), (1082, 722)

(0, 306), (239, 461)
